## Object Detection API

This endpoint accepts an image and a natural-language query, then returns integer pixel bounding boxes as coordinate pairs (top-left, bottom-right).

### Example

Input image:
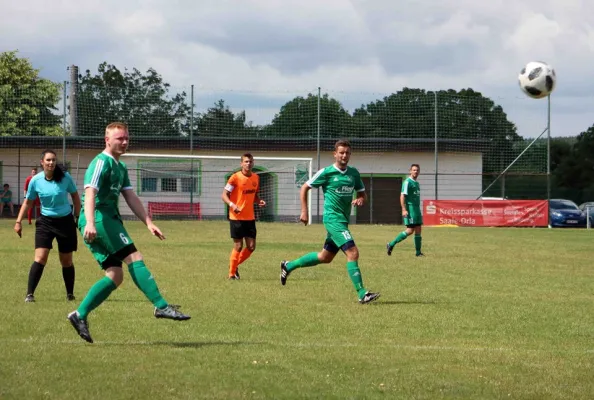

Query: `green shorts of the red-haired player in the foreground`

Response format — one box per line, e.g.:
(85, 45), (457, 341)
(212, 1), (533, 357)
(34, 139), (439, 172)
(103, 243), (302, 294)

(78, 212), (134, 267)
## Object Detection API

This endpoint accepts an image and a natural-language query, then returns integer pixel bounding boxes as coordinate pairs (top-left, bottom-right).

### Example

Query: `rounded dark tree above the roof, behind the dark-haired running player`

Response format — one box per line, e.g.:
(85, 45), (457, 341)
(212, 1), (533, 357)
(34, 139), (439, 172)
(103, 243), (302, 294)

(265, 93), (353, 139)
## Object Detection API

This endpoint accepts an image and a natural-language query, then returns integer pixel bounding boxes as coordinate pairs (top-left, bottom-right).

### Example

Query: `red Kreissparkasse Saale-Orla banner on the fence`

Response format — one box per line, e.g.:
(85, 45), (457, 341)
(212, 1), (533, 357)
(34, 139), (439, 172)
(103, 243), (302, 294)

(423, 200), (549, 226)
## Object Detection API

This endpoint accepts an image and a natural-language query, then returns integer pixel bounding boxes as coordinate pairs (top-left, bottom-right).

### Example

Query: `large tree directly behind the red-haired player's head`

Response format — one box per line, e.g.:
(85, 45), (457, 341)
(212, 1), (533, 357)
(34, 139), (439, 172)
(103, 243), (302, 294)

(77, 62), (190, 136)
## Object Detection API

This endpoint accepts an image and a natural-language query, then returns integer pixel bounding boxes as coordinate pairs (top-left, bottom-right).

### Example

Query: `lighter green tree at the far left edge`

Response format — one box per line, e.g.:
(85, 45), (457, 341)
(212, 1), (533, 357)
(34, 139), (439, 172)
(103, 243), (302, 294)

(0, 50), (63, 136)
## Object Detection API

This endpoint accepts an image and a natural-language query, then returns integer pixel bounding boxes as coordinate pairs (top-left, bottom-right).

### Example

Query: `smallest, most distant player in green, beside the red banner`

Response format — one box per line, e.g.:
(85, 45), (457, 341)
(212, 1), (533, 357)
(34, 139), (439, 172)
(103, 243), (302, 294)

(386, 164), (424, 257)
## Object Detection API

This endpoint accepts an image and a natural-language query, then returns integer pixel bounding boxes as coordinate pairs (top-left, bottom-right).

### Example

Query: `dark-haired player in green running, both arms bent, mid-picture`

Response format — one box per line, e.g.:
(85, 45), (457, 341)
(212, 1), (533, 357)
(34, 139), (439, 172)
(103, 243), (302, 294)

(280, 140), (380, 304)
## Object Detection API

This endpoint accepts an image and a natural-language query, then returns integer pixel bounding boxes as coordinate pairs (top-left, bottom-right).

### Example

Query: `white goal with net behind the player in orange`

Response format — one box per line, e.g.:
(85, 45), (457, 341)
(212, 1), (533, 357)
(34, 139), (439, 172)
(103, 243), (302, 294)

(122, 153), (313, 223)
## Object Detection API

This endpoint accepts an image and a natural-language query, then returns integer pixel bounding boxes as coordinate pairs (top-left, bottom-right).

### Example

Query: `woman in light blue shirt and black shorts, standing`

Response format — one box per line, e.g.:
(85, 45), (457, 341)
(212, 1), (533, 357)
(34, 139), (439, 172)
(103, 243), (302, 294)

(14, 150), (80, 303)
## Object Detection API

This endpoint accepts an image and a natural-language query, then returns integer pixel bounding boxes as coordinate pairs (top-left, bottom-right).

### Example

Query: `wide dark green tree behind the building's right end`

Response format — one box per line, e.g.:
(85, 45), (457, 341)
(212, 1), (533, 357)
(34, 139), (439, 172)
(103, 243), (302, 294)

(353, 88), (522, 173)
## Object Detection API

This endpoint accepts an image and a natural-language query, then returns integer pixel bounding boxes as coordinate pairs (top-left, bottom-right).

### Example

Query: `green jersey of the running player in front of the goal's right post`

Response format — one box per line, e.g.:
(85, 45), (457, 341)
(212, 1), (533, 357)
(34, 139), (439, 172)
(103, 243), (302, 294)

(307, 164), (365, 224)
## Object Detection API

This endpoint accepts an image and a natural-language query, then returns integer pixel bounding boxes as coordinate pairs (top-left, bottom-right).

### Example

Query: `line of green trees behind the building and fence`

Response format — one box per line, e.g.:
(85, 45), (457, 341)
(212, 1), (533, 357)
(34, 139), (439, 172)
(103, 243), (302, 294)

(0, 51), (594, 202)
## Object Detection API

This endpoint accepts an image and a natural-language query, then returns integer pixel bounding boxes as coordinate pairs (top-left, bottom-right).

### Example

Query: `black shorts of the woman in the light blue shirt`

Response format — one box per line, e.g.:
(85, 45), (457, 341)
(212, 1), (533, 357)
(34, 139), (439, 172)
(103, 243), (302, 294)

(35, 214), (78, 253)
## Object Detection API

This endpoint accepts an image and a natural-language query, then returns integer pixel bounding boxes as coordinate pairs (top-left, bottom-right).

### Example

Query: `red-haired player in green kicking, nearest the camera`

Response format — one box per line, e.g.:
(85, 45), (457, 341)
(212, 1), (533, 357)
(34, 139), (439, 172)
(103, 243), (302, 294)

(68, 122), (190, 343)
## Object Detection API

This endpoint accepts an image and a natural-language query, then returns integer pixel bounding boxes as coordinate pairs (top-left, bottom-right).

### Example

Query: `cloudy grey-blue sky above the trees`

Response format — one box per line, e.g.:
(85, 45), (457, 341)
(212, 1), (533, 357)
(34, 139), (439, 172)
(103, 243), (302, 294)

(0, 0), (594, 137)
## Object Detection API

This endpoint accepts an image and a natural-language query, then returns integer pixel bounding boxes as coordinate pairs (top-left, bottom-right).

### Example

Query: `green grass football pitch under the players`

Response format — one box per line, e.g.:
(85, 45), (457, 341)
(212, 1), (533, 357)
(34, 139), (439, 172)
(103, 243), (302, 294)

(0, 219), (594, 400)
